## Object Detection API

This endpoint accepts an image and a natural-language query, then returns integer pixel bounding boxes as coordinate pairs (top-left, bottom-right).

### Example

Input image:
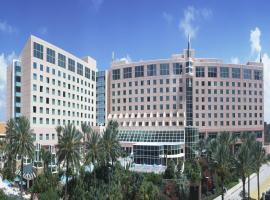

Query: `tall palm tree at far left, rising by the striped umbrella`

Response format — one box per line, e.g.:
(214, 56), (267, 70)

(12, 116), (35, 196)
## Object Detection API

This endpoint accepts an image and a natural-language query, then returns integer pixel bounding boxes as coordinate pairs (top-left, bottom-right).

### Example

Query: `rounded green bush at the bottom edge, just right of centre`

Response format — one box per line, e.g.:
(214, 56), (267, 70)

(139, 181), (159, 200)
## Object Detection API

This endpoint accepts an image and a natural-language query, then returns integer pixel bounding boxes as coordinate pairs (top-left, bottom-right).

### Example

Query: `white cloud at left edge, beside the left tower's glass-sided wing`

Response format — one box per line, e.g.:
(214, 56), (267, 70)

(0, 52), (17, 121)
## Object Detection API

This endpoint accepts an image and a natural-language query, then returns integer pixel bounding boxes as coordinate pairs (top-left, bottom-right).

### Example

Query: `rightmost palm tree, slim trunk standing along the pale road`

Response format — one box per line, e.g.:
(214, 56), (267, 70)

(252, 141), (267, 199)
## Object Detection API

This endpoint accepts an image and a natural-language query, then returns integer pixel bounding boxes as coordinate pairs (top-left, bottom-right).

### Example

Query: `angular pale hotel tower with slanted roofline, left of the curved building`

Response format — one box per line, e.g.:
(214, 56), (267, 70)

(7, 35), (97, 170)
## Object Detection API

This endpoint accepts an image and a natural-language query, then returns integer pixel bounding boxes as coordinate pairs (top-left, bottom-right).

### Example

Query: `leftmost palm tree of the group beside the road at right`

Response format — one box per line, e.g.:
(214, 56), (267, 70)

(209, 133), (233, 200)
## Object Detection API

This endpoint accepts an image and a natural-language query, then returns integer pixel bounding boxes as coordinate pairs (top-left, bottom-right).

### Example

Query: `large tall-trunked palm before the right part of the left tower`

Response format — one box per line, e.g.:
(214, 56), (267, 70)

(57, 124), (82, 199)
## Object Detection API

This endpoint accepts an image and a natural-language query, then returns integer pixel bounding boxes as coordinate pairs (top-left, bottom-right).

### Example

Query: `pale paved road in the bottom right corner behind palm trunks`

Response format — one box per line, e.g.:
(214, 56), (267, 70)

(215, 165), (270, 200)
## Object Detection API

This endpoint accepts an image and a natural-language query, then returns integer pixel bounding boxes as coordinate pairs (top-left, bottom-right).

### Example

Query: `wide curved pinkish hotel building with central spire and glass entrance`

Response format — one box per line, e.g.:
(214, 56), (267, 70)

(108, 43), (264, 164)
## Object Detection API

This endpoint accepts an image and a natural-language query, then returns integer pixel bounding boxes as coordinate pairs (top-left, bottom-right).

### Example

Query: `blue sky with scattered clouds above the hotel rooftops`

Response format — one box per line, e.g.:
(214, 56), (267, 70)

(0, 0), (270, 121)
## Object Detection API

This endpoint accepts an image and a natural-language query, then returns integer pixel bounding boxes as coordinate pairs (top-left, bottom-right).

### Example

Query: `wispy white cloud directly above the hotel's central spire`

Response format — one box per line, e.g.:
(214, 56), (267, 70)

(179, 6), (212, 38)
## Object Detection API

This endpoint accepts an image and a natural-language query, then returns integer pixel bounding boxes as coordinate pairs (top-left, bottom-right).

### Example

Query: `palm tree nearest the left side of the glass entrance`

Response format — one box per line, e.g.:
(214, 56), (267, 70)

(101, 121), (121, 166)
